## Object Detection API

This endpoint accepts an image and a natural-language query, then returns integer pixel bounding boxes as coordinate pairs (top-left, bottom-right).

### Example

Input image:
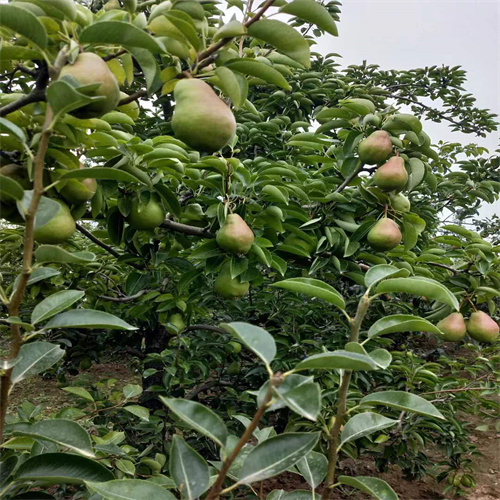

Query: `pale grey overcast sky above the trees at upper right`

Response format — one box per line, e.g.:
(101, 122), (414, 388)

(313, 0), (500, 216)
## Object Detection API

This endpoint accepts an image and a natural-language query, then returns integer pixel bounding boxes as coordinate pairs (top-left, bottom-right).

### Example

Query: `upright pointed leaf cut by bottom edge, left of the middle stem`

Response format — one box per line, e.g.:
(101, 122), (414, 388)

(170, 435), (210, 500)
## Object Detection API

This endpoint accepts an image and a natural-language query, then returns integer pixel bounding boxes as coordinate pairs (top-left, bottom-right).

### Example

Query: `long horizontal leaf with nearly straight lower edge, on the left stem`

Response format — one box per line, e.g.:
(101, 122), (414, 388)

(45, 309), (137, 330)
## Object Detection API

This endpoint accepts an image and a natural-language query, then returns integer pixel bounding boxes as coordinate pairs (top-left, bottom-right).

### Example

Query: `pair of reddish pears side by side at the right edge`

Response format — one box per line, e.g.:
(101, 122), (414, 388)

(436, 311), (500, 343)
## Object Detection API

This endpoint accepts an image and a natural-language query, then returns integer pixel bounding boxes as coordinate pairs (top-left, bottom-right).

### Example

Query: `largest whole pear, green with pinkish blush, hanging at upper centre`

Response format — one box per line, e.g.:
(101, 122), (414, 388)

(172, 78), (236, 153)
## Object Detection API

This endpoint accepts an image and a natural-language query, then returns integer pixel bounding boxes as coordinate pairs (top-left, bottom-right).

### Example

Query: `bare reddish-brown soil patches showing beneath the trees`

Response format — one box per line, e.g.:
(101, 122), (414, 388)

(7, 360), (500, 500)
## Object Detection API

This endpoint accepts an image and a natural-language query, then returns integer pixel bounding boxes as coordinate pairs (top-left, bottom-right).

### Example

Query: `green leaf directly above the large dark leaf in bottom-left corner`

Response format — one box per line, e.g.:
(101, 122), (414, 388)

(14, 418), (94, 457)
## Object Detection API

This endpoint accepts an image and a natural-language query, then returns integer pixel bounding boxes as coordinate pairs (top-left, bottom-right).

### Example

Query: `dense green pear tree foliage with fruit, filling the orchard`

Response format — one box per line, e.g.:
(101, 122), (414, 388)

(0, 0), (500, 500)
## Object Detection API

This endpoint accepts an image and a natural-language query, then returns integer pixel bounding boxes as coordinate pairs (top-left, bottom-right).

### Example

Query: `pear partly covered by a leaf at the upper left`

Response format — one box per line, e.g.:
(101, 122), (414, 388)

(61, 52), (120, 119)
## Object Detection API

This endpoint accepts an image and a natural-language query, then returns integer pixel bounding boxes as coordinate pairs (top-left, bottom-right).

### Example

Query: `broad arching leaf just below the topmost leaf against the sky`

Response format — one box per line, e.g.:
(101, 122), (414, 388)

(248, 19), (311, 68)
